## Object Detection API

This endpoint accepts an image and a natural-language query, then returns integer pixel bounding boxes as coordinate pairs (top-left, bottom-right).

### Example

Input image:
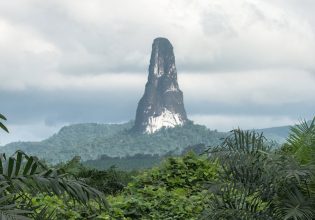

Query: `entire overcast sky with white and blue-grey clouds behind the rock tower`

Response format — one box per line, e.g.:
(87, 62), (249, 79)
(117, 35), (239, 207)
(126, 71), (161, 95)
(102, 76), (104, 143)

(0, 0), (315, 145)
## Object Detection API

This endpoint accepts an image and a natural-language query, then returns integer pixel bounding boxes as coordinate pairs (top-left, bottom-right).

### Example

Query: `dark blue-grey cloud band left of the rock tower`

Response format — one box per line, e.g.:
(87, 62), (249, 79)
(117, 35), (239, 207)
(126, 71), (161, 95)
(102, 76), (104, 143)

(0, 87), (139, 126)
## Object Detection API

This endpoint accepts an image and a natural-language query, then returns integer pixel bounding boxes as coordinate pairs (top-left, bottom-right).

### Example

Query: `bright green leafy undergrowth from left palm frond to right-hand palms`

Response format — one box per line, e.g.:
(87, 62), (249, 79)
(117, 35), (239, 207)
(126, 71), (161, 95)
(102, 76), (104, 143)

(32, 153), (219, 220)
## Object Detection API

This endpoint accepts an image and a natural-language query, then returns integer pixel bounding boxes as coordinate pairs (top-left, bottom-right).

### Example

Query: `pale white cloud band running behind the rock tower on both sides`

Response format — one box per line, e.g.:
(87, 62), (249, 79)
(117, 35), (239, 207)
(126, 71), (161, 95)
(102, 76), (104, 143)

(1, 69), (315, 106)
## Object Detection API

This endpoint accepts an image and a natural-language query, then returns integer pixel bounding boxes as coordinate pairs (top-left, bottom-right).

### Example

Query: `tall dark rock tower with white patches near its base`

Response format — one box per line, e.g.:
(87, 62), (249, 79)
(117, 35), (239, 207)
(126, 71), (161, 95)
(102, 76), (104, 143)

(134, 38), (188, 133)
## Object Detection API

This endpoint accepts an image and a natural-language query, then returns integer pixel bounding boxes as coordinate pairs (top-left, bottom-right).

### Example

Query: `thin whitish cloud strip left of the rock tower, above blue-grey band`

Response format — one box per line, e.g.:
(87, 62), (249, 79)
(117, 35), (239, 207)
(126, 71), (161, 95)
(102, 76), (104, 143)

(0, 73), (146, 91)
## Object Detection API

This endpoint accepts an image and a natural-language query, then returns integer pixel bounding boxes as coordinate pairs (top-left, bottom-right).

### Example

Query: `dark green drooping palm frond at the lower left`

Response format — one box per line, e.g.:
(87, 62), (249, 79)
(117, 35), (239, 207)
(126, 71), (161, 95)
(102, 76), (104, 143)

(0, 151), (104, 204)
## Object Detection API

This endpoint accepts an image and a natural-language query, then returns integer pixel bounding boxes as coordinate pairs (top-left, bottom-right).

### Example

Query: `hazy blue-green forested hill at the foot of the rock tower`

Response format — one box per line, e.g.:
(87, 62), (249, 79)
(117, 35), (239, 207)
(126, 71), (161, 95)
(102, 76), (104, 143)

(1, 121), (226, 164)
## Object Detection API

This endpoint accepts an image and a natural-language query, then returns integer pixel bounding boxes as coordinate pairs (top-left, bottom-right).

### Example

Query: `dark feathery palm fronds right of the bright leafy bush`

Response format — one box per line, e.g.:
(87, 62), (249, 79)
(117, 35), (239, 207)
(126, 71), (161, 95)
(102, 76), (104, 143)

(204, 129), (315, 220)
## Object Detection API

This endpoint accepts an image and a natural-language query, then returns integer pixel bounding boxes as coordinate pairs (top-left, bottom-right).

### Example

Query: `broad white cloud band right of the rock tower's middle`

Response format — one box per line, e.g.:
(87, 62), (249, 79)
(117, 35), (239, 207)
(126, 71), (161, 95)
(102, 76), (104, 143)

(178, 69), (315, 107)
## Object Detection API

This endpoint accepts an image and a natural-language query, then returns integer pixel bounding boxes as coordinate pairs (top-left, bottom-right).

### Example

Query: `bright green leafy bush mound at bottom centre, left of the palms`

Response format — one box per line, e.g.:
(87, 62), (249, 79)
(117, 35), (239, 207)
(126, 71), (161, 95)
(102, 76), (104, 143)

(109, 153), (218, 219)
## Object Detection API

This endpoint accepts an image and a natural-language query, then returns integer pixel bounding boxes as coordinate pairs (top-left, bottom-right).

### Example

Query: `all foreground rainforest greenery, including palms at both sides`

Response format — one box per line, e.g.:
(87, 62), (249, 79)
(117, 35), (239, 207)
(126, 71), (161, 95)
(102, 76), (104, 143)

(0, 114), (315, 220)
